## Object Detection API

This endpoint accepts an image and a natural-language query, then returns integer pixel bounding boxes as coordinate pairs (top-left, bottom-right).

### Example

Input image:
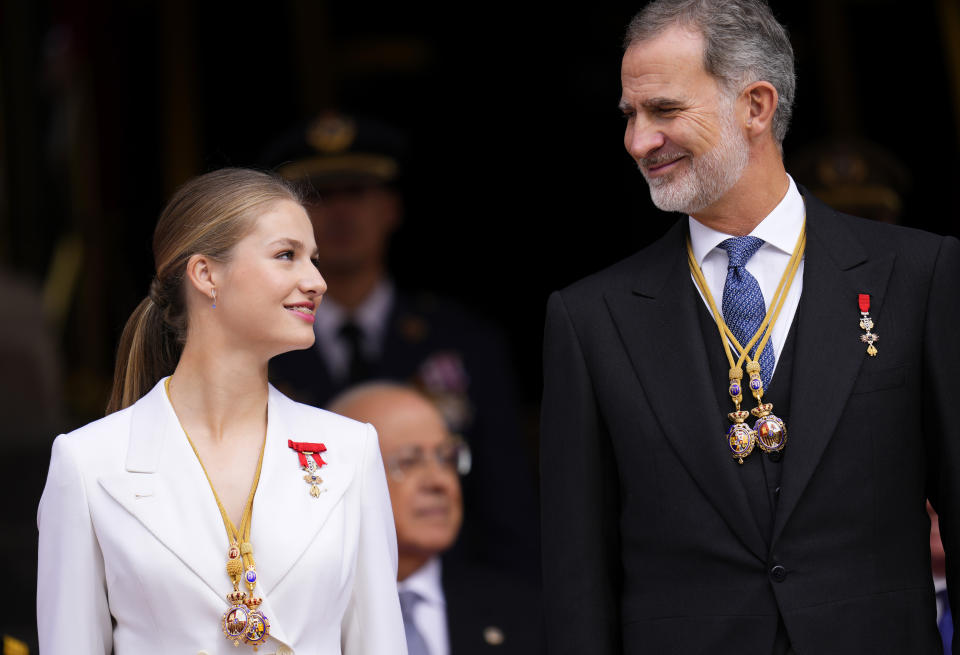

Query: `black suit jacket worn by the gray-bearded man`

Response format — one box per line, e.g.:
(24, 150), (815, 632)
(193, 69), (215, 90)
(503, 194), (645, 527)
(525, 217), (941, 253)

(541, 196), (960, 655)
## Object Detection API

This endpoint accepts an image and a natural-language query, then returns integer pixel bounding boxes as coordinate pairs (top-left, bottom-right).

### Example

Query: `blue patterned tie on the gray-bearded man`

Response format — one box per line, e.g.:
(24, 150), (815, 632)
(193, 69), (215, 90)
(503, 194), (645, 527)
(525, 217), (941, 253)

(720, 237), (776, 389)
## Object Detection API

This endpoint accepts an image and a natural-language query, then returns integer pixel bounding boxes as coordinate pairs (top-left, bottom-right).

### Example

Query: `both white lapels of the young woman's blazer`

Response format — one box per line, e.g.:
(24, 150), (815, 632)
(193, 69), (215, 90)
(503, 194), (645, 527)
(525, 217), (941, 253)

(99, 380), (355, 643)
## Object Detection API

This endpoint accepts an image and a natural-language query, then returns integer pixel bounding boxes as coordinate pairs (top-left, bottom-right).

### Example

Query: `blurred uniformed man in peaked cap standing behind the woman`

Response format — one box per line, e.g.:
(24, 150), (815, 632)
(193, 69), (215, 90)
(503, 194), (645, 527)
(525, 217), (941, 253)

(264, 112), (537, 573)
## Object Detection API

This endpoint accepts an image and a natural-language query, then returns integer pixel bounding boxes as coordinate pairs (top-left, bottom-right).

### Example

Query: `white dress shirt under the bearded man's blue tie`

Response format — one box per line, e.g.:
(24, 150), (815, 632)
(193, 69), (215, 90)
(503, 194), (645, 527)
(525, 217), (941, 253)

(688, 176), (806, 374)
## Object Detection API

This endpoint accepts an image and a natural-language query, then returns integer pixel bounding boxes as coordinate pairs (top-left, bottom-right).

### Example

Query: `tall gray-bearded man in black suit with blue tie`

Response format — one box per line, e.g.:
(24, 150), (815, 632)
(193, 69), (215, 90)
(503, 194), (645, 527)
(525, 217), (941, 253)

(541, 0), (960, 655)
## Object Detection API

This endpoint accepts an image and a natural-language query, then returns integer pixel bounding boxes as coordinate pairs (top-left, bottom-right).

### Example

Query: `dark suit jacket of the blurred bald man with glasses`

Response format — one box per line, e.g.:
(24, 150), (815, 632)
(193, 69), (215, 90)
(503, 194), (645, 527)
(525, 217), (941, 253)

(442, 559), (546, 655)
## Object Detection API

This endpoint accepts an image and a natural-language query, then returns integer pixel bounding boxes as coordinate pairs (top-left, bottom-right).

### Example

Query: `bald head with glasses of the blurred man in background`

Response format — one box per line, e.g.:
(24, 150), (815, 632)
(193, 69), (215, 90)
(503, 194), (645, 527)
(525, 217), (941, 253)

(328, 383), (463, 580)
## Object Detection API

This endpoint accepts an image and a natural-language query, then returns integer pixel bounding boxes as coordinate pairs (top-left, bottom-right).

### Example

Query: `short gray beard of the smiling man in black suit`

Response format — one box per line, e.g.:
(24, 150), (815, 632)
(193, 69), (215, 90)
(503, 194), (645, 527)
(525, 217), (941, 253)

(640, 109), (750, 214)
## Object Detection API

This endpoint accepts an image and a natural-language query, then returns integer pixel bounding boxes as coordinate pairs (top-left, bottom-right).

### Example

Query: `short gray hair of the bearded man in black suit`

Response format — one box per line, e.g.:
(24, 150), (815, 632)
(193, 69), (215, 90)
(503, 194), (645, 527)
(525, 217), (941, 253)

(624, 0), (797, 147)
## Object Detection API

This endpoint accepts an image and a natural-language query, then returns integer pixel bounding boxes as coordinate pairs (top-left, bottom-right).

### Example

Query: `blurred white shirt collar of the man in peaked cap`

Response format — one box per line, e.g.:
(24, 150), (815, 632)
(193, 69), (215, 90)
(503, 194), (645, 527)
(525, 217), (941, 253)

(313, 280), (396, 381)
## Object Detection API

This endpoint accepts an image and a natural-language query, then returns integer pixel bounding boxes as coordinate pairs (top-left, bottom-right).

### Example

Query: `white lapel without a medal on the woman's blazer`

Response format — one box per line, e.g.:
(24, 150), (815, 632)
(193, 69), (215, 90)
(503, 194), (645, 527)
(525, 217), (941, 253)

(98, 380), (230, 603)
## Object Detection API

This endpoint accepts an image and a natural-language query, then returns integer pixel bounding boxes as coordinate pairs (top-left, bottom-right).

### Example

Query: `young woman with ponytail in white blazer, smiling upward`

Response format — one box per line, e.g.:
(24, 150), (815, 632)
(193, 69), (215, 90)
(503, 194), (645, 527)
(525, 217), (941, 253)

(37, 169), (406, 655)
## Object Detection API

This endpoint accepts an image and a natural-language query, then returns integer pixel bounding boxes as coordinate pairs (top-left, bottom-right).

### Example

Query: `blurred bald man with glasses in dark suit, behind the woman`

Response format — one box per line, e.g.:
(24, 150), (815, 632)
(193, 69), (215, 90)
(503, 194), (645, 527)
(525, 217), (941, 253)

(329, 383), (544, 655)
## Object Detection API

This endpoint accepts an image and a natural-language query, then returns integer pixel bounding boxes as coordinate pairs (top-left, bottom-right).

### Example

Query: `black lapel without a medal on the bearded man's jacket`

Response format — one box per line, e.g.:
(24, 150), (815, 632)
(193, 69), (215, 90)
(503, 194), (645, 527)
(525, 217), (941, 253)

(604, 219), (767, 561)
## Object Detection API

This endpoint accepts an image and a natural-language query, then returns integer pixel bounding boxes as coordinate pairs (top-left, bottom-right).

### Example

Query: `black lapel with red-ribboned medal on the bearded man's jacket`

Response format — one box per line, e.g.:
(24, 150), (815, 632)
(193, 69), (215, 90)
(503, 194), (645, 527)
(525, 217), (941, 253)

(772, 194), (894, 546)
